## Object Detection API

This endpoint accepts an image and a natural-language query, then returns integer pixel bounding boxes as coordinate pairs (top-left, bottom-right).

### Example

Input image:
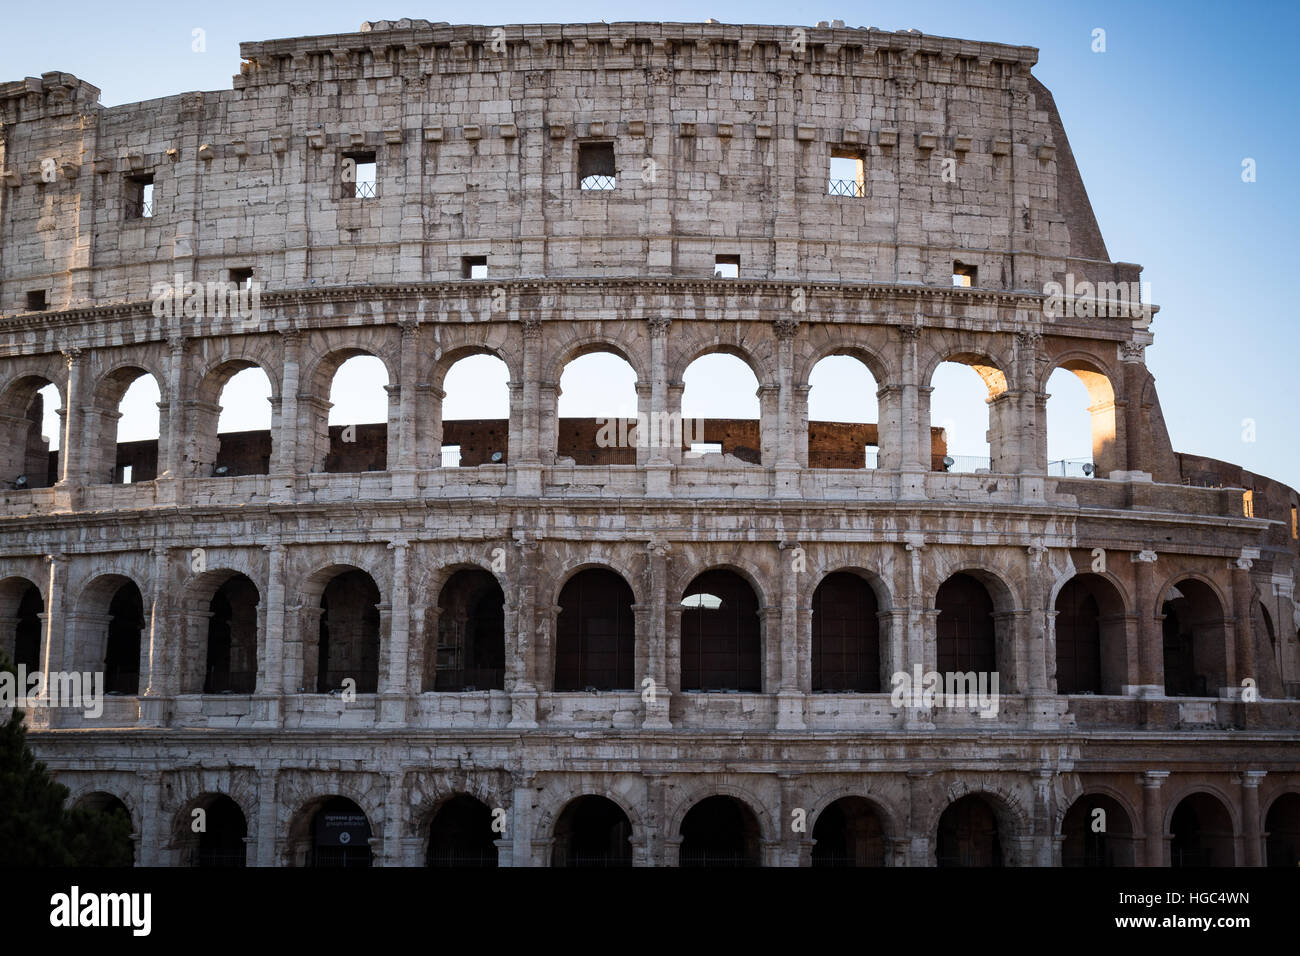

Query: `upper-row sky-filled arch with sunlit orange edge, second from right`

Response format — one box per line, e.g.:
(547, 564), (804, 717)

(930, 355), (1015, 473)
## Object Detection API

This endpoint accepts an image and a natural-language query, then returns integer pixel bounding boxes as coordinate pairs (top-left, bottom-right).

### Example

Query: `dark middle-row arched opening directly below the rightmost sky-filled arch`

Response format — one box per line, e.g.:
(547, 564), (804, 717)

(1056, 574), (1128, 695)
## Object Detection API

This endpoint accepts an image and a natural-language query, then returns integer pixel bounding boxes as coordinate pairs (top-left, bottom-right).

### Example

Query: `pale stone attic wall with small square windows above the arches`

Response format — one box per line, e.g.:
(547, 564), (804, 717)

(0, 22), (1130, 312)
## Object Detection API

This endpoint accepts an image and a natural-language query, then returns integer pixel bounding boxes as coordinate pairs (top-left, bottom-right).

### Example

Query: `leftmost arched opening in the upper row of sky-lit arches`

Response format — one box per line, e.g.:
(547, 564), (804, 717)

(0, 376), (62, 490)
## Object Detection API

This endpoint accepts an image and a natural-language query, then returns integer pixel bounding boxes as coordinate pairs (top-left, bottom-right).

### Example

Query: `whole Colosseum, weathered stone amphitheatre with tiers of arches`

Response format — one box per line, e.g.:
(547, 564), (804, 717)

(0, 20), (1300, 866)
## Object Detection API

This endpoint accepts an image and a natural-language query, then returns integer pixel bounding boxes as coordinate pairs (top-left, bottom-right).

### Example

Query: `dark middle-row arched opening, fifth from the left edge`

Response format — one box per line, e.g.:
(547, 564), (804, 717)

(423, 568), (506, 692)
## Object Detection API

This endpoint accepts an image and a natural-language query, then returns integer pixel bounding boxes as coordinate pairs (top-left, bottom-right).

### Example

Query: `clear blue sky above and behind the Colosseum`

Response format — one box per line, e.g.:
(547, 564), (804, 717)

(0, 0), (1300, 486)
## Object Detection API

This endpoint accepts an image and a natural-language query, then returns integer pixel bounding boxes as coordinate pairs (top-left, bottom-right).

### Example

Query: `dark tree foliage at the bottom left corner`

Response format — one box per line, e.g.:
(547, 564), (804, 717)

(0, 650), (131, 866)
